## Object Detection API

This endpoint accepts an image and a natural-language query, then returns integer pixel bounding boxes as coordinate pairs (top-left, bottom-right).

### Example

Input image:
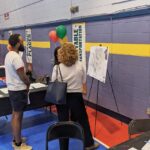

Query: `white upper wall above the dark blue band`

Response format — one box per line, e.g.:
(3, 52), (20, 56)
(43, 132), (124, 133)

(0, 0), (150, 29)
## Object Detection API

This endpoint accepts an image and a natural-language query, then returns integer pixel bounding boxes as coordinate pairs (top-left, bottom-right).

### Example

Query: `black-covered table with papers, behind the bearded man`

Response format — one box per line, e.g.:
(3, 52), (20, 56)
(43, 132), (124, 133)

(0, 83), (51, 116)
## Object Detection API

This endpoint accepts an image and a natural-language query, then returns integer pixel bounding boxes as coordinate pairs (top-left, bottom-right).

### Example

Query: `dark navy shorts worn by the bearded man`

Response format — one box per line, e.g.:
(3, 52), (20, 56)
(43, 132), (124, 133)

(8, 90), (28, 111)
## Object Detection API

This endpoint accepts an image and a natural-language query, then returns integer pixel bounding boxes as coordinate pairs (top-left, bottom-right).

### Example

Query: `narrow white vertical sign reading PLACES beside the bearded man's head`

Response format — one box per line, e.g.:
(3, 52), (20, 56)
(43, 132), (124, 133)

(25, 29), (32, 63)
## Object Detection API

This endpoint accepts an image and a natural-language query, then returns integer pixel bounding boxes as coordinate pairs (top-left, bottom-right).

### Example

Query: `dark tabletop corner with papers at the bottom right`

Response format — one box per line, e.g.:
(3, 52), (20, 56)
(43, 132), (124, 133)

(109, 131), (150, 150)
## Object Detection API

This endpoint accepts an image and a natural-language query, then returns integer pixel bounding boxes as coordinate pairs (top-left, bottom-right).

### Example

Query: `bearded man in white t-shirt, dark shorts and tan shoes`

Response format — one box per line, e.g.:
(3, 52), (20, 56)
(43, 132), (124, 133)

(5, 34), (32, 150)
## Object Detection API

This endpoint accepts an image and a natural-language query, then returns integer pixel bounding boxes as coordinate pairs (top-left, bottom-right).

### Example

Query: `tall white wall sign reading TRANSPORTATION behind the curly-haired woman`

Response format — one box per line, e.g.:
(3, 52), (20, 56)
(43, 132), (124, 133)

(72, 23), (86, 69)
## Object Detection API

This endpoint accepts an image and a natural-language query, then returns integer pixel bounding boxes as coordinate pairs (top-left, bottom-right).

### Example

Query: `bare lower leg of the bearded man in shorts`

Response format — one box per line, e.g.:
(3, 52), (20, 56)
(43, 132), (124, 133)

(11, 111), (23, 143)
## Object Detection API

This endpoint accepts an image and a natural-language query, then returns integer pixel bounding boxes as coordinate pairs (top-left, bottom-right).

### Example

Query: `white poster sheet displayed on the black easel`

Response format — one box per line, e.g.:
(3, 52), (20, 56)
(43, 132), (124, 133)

(87, 46), (109, 83)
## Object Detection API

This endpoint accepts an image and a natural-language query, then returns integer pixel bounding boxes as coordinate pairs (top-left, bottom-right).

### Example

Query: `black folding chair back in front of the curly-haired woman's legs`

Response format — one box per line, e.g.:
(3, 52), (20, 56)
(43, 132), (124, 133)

(46, 121), (84, 150)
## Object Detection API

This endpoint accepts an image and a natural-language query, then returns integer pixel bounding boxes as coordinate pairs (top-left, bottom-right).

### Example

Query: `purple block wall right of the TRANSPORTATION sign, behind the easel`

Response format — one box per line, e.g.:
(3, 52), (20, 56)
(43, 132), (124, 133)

(87, 16), (150, 118)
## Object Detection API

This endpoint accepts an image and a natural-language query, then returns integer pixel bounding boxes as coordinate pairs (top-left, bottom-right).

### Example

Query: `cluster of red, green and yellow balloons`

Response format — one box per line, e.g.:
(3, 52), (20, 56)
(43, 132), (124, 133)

(48, 25), (68, 44)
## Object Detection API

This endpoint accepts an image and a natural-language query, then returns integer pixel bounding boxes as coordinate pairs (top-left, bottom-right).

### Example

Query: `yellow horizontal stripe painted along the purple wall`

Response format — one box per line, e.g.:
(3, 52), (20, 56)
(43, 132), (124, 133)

(0, 40), (150, 57)
